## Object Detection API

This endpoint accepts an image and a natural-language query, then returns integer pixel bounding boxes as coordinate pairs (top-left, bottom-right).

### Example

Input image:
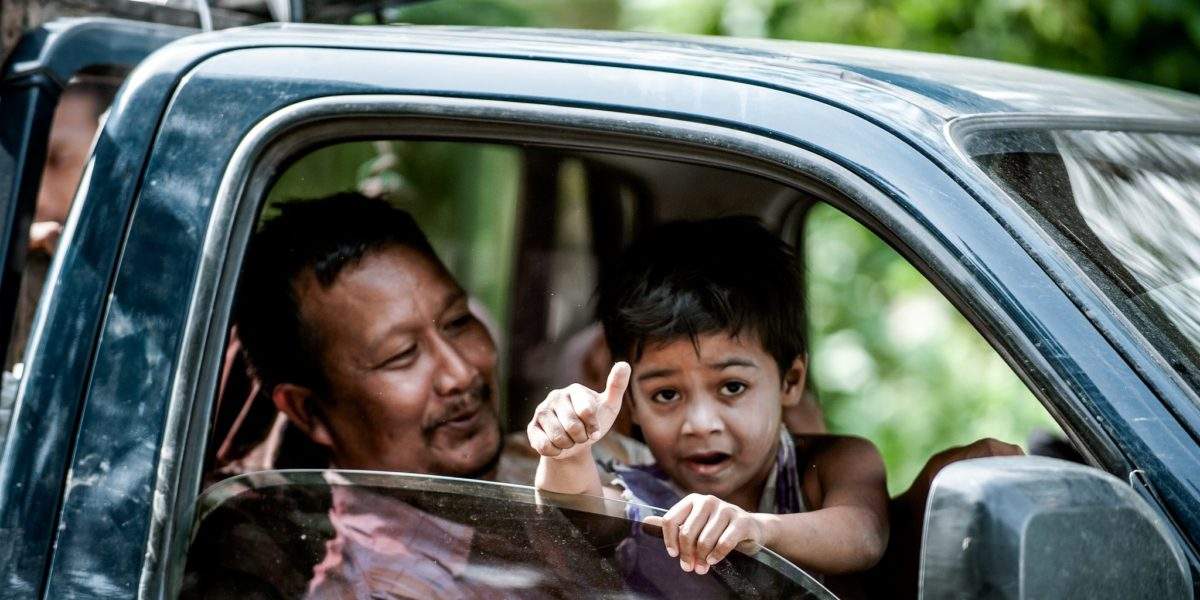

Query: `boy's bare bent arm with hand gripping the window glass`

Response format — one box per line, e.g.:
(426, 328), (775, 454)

(647, 438), (888, 575)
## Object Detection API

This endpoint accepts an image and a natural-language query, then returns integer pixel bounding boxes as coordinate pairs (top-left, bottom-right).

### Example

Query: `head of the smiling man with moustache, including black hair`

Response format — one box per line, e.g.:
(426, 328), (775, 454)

(236, 194), (503, 479)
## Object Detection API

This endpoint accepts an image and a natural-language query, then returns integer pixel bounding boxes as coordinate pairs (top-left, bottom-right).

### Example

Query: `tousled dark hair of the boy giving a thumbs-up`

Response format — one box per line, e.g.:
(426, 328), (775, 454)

(598, 217), (808, 376)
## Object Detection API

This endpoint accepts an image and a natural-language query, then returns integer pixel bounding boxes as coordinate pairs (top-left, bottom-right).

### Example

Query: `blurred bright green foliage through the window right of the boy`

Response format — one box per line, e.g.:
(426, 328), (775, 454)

(804, 205), (1058, 492)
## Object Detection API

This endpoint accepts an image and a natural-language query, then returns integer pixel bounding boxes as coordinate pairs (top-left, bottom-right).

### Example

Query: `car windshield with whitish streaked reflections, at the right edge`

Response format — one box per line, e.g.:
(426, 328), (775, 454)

(959, 128), (1200, 398)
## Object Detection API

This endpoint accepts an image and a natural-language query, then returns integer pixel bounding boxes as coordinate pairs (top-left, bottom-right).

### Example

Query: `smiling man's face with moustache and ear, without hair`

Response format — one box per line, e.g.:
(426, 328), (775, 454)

(295, 246), (500, 476)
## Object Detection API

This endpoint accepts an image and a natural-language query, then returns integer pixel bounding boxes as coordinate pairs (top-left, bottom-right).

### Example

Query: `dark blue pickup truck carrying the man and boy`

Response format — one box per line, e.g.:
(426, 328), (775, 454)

(0, 18), (1200, 598)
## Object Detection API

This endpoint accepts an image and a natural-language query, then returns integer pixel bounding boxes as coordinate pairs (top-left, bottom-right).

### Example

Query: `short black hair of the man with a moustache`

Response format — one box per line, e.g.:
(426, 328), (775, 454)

(234, 192), (440, 392)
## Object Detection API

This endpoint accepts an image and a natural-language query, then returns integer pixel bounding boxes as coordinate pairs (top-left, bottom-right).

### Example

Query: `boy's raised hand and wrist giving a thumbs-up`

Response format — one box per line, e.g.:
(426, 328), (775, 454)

(526, 362), (631, 496)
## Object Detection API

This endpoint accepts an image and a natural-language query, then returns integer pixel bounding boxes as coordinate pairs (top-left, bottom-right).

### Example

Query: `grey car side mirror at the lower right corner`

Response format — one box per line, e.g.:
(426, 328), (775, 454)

(919, 456), (1192, 600)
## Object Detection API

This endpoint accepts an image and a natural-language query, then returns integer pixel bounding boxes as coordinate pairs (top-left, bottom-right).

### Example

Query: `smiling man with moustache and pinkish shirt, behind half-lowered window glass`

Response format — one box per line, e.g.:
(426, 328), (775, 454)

(207, 193), (580, 598)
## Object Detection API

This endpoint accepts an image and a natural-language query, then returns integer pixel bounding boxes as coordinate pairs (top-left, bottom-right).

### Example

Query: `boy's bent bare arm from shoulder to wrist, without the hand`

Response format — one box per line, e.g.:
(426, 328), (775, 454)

(755, 437), (888, 575)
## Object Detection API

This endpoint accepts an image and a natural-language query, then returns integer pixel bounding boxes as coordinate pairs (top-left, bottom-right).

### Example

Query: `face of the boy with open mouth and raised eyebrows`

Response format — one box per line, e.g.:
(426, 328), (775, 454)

(630, 332), (804, 510)
